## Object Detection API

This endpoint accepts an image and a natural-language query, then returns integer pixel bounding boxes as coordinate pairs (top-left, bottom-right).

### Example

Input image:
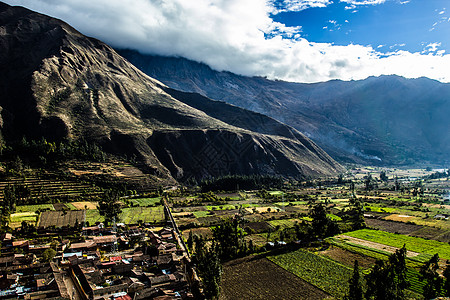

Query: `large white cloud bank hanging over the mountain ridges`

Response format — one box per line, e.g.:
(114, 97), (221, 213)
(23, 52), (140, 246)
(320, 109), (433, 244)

(6, 0), (450, 82)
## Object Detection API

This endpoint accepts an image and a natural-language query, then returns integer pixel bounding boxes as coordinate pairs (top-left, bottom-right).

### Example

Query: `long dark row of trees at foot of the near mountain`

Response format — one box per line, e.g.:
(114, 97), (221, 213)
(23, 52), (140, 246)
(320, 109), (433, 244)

(200, 175), (283, 192)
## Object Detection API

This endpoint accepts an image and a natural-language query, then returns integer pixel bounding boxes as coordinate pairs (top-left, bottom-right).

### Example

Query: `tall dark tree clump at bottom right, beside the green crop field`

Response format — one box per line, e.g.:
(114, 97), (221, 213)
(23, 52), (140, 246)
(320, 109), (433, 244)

(366, 246), (409, 300)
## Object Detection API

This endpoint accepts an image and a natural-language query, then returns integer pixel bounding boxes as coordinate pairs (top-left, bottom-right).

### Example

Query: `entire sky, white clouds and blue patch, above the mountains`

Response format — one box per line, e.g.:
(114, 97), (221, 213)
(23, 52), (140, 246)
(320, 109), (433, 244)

(3, 0), (450, 82)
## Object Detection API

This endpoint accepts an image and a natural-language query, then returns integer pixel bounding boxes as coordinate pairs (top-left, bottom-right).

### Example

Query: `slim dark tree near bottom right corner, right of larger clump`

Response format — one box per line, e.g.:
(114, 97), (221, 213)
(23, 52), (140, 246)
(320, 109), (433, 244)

(420, 253), (443, 299)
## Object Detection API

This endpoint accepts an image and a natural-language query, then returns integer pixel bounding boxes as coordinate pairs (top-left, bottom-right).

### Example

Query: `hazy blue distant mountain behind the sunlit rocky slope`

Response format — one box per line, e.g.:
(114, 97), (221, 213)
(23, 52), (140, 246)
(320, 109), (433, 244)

(119, 50), (450, 165)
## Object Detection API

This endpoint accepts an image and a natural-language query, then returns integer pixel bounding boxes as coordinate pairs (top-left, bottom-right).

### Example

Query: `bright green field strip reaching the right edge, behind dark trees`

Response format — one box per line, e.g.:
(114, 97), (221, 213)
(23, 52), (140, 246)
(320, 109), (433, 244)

(346, 229), (450, 259)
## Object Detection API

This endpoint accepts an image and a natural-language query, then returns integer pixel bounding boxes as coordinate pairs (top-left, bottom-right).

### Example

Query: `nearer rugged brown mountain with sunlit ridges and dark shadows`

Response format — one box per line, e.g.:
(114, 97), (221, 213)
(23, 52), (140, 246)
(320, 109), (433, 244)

(0, 3), (343, 182)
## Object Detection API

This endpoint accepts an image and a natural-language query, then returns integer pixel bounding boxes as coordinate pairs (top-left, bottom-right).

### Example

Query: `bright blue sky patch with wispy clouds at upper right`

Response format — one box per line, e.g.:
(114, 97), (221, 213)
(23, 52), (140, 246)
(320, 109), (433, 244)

(272, 0), (450, 53)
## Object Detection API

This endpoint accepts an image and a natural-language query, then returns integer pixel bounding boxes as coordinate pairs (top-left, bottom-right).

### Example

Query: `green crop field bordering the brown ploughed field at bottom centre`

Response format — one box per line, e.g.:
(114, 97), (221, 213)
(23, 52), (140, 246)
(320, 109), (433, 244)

(268, 249), (353, 298)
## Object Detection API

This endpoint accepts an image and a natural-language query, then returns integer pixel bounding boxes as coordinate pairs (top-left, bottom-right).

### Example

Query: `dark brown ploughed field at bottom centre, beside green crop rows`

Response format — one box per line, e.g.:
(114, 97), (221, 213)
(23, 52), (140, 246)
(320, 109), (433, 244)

(219, 256), (329, 300)
